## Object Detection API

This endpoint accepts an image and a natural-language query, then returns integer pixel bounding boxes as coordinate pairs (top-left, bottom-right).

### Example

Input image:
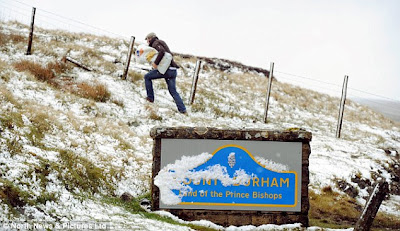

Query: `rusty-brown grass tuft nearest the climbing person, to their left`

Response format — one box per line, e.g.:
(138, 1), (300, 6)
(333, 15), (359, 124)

(76, 82), (111, 102)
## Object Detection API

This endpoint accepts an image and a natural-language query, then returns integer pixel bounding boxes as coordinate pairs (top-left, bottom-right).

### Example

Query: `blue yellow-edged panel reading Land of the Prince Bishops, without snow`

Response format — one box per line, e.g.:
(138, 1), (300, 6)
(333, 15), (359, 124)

(173, 144), (298, 207)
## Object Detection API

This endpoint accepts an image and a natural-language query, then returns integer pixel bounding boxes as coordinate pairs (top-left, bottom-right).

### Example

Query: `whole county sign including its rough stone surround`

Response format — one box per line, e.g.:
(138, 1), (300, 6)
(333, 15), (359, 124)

(150, 127), (312, 226)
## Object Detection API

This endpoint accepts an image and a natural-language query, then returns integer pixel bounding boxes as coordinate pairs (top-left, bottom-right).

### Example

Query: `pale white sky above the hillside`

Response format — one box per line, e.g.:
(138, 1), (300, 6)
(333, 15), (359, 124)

(0, 0), (400, 101)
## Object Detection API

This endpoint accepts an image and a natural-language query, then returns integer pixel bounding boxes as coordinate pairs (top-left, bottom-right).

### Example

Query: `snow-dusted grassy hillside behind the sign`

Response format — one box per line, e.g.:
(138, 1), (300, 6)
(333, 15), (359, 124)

(0, 20), (400, 230)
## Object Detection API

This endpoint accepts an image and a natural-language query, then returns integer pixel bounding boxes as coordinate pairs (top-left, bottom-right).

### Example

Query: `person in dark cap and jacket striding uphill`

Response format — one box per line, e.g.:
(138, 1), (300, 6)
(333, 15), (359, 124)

(144, 32), (187, 114)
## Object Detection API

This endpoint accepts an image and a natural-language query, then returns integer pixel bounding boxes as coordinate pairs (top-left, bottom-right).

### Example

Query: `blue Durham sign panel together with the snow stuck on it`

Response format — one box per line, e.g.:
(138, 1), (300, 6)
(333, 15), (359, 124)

(155, 144), (301, 207)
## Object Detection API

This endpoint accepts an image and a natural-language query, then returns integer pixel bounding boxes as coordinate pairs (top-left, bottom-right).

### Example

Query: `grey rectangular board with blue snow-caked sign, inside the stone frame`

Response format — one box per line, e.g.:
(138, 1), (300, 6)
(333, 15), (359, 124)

(154, 139), (302, 212)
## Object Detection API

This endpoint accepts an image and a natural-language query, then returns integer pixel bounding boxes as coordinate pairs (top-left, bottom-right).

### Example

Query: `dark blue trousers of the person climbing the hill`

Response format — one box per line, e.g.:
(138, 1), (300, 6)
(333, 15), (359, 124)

(144, 69), (186, 113)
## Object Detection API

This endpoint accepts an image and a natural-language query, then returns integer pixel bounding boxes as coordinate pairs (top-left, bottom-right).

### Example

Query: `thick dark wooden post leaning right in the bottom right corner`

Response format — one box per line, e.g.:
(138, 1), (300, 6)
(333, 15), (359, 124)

(354, 180), (389, 231)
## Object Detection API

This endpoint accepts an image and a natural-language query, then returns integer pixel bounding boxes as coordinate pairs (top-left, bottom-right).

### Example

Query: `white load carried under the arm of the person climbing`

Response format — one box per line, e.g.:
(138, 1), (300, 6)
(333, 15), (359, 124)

(135, 44), (172, 74)
